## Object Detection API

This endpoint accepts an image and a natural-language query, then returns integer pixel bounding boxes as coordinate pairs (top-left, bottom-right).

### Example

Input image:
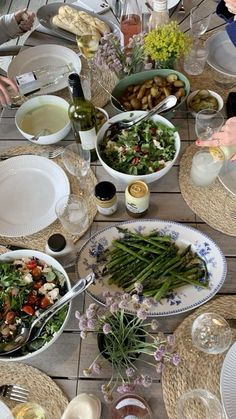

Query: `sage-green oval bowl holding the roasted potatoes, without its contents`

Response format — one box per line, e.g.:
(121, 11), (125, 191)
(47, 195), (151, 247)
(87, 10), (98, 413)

(110, 68), (190, 115)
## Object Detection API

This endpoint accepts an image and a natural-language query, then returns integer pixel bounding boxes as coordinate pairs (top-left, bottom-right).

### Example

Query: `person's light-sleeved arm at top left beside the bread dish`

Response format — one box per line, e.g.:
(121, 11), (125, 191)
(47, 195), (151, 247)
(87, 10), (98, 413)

(0, 9), (35, 44)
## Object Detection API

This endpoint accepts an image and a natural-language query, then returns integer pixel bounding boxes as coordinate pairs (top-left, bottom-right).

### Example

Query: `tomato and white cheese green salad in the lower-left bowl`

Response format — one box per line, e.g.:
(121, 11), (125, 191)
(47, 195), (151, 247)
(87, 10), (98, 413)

(0, 257), (68, 356)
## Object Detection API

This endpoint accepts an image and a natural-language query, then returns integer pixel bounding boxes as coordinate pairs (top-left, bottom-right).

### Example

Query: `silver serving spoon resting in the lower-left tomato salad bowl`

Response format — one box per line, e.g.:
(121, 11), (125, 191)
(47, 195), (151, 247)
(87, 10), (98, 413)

(0, 272), (95, 356)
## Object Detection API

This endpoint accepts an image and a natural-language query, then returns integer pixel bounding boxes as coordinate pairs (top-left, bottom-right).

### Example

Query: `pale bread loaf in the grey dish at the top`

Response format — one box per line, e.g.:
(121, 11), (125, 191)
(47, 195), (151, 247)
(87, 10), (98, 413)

(52, 6), (111, 38)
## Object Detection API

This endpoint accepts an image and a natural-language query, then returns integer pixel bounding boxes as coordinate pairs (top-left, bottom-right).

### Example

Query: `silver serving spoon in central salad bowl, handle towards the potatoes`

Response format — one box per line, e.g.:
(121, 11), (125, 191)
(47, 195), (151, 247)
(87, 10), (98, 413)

(104, 95), (177, 138)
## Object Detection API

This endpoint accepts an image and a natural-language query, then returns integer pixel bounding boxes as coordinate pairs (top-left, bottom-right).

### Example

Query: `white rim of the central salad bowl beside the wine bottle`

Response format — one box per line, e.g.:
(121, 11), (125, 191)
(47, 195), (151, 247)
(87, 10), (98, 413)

(95, 110), (181, 182)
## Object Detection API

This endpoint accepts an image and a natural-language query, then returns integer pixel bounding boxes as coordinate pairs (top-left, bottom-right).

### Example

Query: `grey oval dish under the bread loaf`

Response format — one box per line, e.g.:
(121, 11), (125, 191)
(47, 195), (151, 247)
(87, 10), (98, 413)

(37, 0), (120, 42)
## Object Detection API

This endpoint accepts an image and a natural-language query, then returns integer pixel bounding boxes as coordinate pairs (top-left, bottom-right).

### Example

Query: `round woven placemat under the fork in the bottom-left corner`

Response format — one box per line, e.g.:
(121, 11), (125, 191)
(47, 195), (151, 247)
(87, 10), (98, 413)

(0, 362), (68, 419)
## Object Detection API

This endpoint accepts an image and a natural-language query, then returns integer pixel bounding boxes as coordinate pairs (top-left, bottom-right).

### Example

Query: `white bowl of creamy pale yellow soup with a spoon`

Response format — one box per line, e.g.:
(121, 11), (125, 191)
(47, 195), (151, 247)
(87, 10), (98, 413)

(15, 95), (71, 145)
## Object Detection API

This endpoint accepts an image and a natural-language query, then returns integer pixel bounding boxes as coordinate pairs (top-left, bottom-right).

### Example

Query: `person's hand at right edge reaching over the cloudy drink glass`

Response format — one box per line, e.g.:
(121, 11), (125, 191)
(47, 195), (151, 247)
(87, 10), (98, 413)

(195, 116), (236, 160)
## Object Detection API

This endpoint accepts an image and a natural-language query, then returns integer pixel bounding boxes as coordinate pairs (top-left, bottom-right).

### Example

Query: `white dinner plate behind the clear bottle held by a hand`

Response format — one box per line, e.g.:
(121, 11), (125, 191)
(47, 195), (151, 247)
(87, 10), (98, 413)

(8, 44), (81, 95)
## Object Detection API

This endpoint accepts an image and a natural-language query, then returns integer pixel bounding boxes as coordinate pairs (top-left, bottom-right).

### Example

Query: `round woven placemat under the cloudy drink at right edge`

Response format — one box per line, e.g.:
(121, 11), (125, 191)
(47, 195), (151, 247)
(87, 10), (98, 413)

(179, 145), (236, 236)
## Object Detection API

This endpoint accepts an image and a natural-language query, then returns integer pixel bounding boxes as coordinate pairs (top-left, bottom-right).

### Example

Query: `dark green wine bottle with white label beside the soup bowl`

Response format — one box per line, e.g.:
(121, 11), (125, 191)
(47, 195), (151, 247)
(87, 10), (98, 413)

(68, 73), (97, 161)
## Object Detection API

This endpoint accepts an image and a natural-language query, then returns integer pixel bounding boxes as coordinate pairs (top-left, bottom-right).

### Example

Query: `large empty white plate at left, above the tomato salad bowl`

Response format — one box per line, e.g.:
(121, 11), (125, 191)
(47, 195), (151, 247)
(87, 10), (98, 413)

(0, 155), (70, 237)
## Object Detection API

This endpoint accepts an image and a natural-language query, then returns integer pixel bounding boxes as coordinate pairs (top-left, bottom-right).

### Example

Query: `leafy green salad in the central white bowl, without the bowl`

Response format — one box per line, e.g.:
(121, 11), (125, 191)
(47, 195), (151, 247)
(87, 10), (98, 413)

(100, 119), (176, 175)
